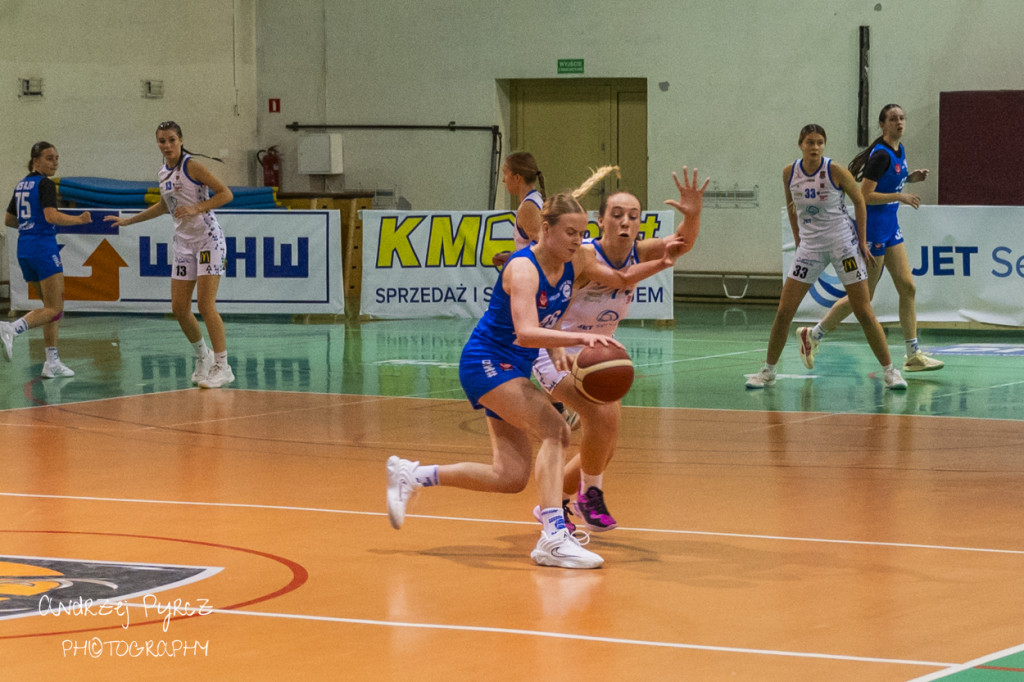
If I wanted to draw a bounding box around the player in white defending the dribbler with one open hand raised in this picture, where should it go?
[534,167,708,531]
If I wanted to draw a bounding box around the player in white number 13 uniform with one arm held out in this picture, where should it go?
[105,121,234,388]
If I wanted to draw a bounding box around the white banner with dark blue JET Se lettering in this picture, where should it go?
[782,206,1024,327]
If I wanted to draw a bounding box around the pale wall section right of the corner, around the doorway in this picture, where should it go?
[251,0,1024,272]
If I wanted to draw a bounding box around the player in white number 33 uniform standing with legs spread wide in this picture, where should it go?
[746,124,906,390]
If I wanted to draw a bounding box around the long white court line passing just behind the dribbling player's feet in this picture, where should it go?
[0,493,1024,556]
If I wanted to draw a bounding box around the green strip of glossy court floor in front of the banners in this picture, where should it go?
[0,303,1024,420]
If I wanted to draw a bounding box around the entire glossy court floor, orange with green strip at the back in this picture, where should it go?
[0,304,1024,680]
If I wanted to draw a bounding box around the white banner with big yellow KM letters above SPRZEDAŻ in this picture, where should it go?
[359,211,676,319]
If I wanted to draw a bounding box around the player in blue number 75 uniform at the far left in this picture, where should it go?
[0,142,92,379]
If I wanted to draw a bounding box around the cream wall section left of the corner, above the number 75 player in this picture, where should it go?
[0,0,257,280]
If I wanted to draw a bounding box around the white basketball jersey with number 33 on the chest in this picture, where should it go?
[790,157,857,251]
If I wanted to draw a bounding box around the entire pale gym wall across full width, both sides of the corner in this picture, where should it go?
[0,0,1024,280]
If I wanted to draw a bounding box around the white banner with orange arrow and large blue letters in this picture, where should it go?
[8,209,344,314]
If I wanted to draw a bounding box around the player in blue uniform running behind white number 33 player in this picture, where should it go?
[797,104,944,372]
